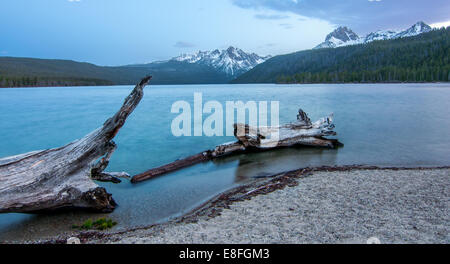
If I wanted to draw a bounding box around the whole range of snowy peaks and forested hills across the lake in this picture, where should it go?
[0,22,450,87]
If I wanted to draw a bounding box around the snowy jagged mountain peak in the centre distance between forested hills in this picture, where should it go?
[172,47,270,76]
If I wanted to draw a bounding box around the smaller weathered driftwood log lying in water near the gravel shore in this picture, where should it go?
[131,109,342,183]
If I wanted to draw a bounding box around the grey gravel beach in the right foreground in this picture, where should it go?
[93,169,450,244]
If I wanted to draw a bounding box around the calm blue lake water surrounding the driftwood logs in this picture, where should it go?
[0,84,450,241]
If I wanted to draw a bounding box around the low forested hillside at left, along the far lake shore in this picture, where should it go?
[0,57,230,87]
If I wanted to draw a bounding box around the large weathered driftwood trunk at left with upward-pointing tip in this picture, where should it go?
[0,76,151,213]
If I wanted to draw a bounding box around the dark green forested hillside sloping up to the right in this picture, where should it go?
[233,27,450,83]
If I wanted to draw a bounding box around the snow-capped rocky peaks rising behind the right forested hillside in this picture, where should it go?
[314,21,431,49]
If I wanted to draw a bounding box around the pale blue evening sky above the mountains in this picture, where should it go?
[0,0,450,65]
